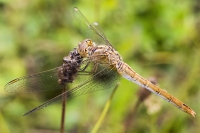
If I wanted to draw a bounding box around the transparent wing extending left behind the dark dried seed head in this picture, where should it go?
[5,67,63,93]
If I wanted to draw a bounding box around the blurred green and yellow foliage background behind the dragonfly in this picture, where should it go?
[0,0,200,133]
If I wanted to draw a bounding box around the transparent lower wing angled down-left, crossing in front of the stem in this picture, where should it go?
[24,65,120,115]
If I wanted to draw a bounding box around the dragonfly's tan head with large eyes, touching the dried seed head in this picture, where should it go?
[77,39,94,57]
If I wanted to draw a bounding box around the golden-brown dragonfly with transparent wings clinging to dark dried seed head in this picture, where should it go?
[5,7,196,117]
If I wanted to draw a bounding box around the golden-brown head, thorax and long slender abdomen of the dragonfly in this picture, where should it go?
[78,39,196,117]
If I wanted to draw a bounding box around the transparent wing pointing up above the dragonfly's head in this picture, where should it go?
[73,7,112,46]
